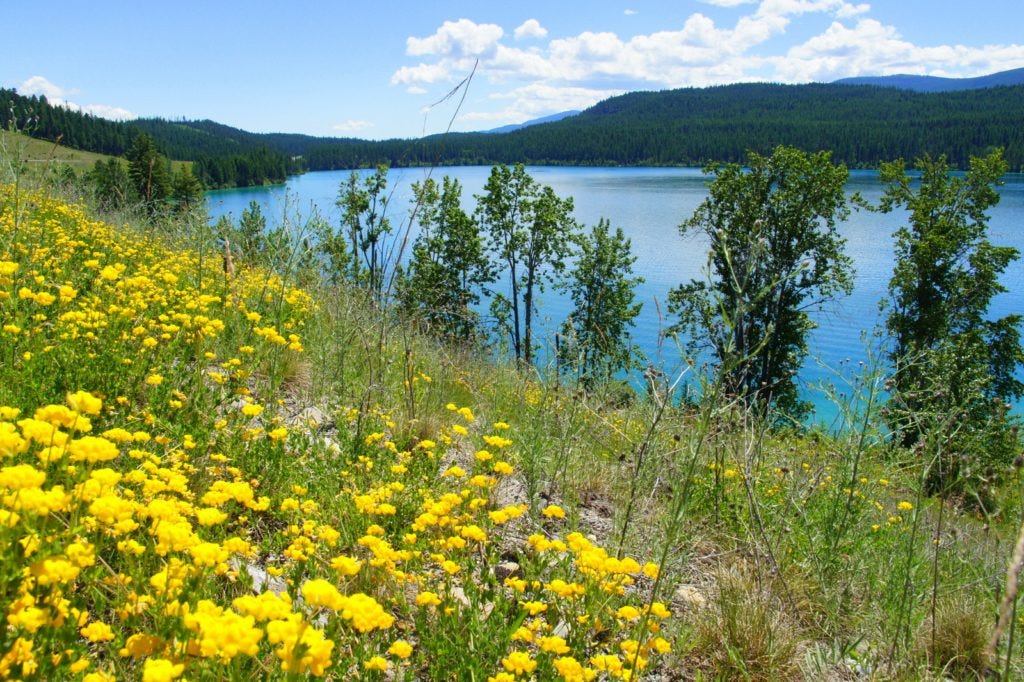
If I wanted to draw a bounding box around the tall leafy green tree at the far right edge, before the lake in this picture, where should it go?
[881,151,1024,505]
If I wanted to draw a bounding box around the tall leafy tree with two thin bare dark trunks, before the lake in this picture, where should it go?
[476,164,577,365]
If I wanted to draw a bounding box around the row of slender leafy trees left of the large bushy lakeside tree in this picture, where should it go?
[216,164,642,386]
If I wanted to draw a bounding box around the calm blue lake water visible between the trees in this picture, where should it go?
[207,166,1024,422]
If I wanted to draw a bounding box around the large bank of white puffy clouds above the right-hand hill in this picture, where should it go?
[391,0,1024,129]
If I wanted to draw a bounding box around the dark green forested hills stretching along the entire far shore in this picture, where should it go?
[0,79,1024,187]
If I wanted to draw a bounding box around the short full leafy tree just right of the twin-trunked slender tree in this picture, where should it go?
[559,219,643,388]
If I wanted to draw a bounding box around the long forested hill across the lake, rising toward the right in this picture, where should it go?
[305,84,1024,170]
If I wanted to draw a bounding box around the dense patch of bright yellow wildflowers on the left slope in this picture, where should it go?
[0,187,671,682]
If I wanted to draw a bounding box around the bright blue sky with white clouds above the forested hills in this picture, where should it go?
[6,0,1024,139]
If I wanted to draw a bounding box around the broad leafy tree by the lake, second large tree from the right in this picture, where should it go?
[669,146,853,419]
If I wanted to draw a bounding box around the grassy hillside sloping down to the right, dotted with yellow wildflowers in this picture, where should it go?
[0,163,1024,682]
